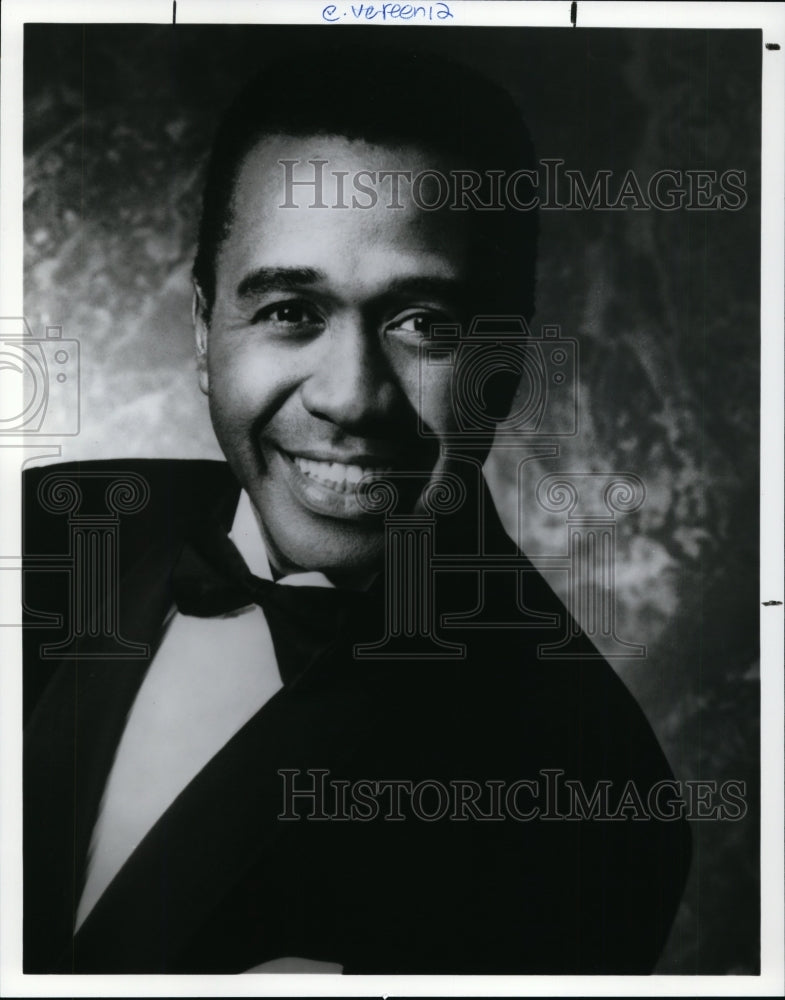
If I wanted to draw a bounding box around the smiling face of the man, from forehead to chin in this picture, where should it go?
[196,136,480,579]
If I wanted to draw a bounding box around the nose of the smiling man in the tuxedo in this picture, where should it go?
[302,319,400,435]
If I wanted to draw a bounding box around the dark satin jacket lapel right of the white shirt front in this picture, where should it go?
[64,636,402,973]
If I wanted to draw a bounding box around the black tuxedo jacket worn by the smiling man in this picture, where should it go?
[24,461,689,974]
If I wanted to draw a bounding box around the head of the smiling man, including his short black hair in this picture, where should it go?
[187,46,537,579]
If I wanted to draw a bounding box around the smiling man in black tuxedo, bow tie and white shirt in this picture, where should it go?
[25,44,689,973]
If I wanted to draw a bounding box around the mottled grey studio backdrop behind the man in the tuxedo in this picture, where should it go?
[24,25,761,973]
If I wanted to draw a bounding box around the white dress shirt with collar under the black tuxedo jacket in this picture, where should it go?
[76,491,332,930]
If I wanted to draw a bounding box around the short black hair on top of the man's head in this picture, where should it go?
[193,39,538,319]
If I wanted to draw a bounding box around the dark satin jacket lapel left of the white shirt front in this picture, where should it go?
[25,536,181,968]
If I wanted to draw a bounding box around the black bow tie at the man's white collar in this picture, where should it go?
[172,523,368,684]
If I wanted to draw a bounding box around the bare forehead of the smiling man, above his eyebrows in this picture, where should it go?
[220,134,467,275]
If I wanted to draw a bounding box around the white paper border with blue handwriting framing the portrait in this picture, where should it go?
[0,0,785,997]
